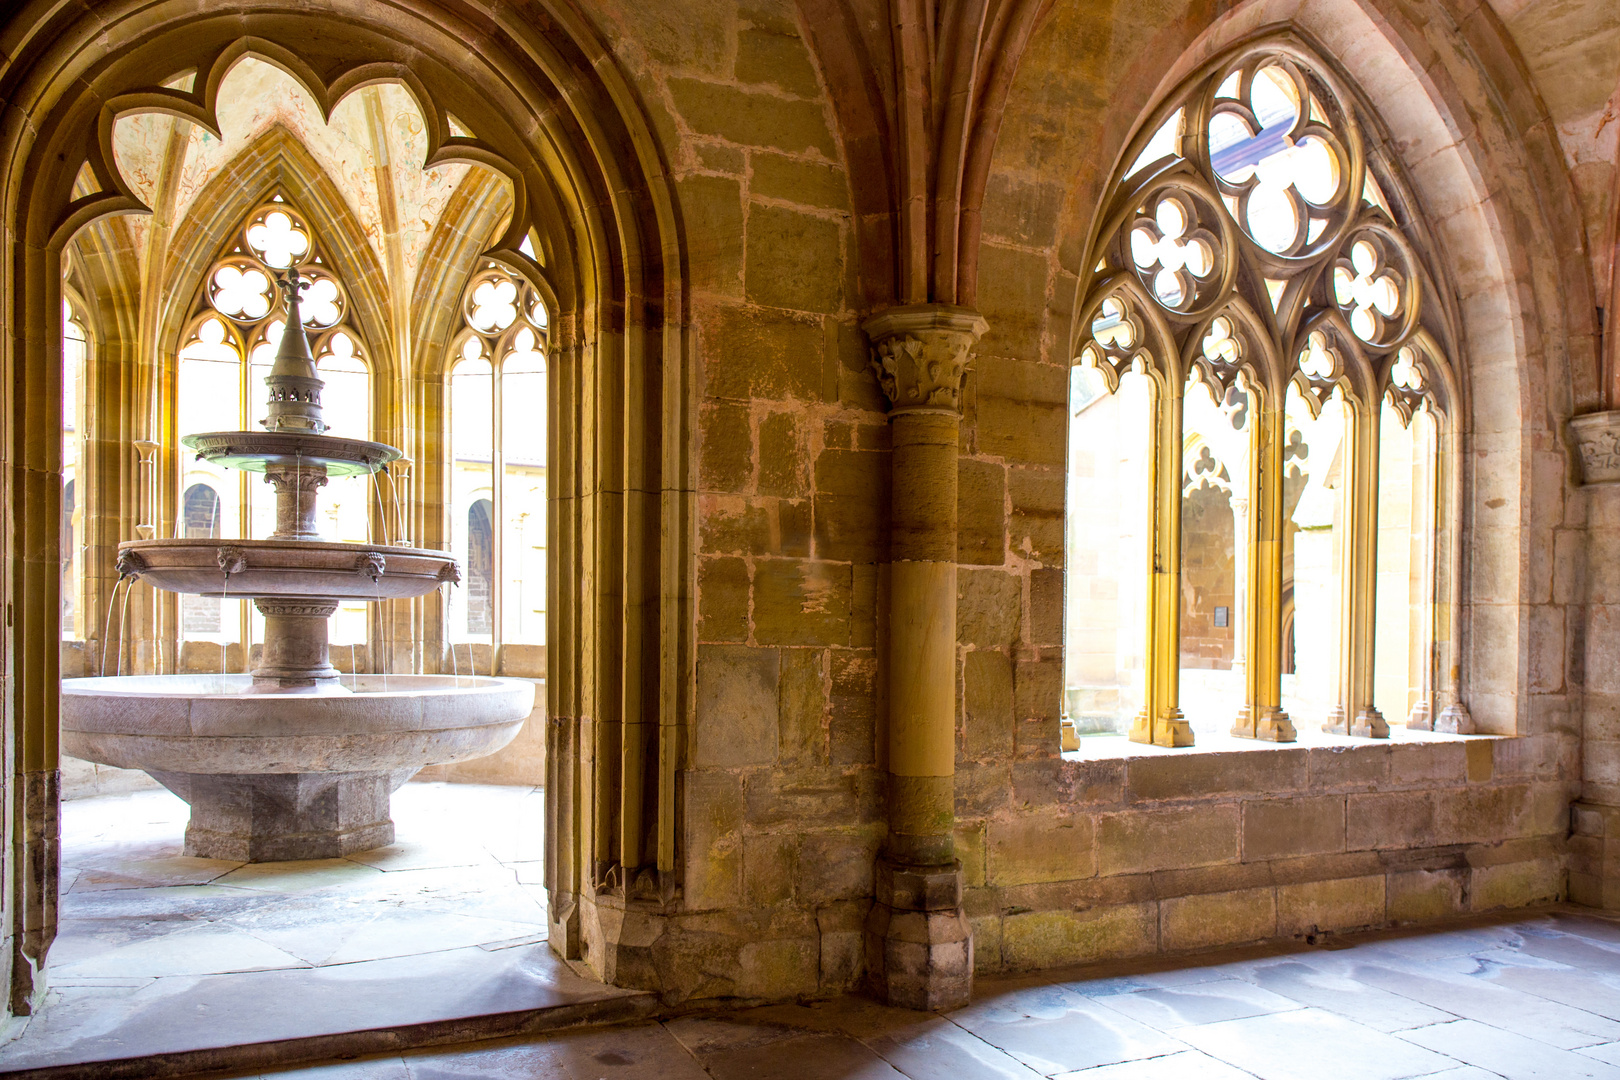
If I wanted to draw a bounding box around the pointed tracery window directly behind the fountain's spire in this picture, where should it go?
[175,196,376,644]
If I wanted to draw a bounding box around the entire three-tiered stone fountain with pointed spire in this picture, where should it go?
[62,269,535,861]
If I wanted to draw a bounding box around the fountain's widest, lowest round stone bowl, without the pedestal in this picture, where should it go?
[62,675,535,774]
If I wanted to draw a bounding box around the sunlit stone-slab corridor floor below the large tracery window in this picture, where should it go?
[249,912,1620,1080]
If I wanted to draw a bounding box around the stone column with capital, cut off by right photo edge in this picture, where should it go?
[1568,411,1620,910]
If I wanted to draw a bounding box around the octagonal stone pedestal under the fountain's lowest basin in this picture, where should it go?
[149,769,416,863]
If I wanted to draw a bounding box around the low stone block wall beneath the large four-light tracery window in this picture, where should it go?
[957,738,1573,972]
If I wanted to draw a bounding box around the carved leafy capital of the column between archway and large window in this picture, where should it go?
[860,304,988,415]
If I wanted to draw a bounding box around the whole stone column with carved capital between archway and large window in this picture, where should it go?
[862,304,985,1009]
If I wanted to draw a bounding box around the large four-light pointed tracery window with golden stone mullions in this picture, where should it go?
[1064,40,1453,746]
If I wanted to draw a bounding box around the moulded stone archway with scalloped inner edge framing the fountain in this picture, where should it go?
[0,0,695,1014]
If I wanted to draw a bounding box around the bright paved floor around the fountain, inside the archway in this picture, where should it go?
[0,784,641,1072]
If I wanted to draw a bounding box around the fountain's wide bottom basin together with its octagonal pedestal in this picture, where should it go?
[62,675,535,863]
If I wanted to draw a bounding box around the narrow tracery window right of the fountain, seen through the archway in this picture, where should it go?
[449,262,549,648]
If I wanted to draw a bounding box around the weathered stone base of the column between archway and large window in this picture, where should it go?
[867,857,974,1012]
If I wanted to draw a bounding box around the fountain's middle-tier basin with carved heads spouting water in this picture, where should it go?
[118,538,460,601]
